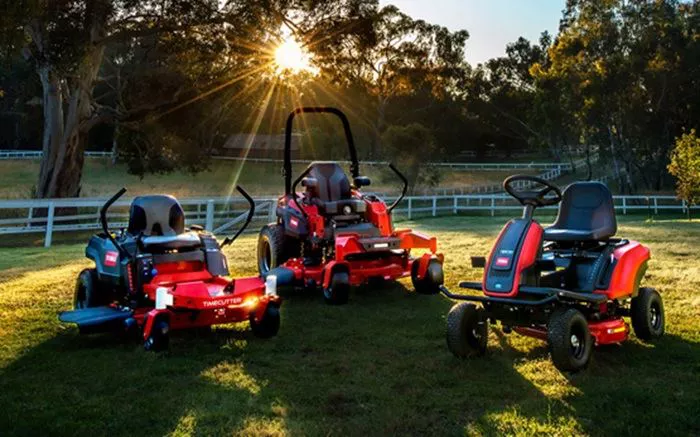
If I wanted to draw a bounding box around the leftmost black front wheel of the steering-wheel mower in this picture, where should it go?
[447,302,489,358]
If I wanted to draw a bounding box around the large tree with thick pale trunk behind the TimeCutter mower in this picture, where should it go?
[5,0,279,197]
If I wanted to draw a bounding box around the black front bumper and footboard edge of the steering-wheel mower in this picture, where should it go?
[440,281,607,306]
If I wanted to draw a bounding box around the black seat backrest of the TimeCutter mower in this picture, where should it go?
[127,194,185,237]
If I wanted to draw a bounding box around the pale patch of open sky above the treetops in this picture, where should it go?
[379,0,565,65]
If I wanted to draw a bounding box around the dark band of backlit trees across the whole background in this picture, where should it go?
[0,0,700,197]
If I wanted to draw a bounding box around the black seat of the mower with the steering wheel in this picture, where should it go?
[544,182,617,241]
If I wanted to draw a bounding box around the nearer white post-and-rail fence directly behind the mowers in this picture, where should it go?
[0,193,688,247]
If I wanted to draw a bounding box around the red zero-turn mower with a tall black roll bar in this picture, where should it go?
[258,107,443,304]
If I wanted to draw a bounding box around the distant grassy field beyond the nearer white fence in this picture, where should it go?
[0,158,532,199]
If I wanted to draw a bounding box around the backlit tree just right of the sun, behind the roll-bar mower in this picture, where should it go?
[304,1,469,157]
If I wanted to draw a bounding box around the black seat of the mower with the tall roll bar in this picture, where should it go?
[309,161,367,216]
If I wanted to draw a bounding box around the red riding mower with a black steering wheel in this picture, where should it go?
[441,175,664,371]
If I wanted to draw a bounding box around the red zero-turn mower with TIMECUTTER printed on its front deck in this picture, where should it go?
[59,187,281,351]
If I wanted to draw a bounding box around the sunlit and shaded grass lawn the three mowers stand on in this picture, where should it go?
[0,217,700,436]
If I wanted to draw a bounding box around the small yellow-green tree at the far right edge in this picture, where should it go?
[668,129,700,220]
